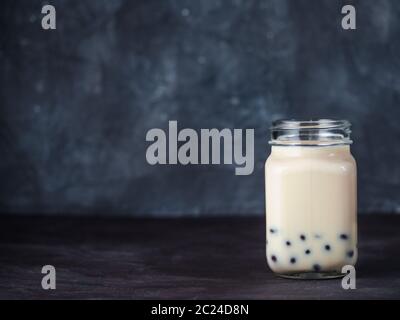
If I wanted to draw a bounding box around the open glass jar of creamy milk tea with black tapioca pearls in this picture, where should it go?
[265,120,357,279]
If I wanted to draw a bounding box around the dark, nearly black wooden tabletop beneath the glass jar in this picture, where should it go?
[0,215,400,299]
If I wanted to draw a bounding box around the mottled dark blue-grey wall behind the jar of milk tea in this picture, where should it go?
[0,0,400,216]
